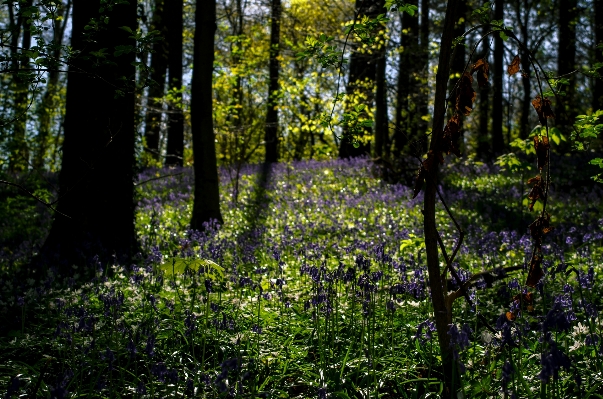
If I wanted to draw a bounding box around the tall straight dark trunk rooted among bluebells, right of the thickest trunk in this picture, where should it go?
[191,0,222,230]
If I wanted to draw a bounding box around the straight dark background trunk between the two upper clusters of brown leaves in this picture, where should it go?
[492,0,505,155]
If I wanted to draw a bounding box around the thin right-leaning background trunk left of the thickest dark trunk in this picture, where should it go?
[33,0,71,169]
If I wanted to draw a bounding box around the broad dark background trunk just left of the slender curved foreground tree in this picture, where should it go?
[394,1,420,158]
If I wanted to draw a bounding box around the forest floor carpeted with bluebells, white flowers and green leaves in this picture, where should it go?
[0,158,603,398]
